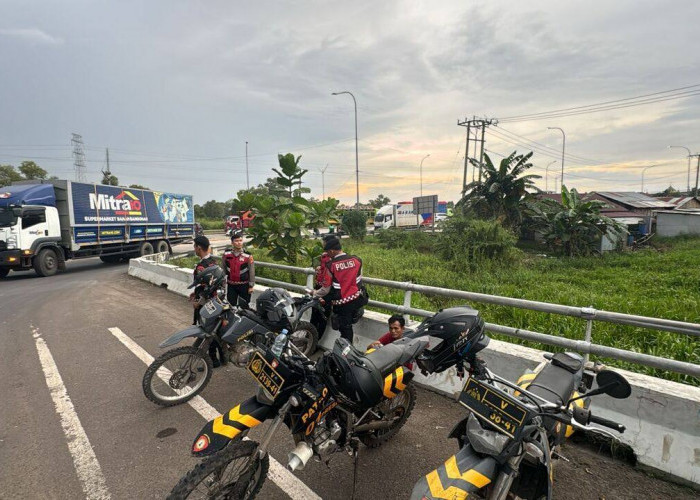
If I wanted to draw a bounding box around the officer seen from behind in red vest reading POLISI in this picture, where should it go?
[314,238,367,343]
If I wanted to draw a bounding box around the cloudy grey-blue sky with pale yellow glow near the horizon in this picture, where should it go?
[0,0,700,203]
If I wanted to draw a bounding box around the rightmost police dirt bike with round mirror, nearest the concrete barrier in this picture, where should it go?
[411,308,631,500]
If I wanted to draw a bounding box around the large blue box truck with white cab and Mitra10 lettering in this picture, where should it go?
[0,180,194,278]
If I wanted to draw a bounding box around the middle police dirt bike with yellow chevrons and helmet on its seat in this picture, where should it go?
[168,326,427,499]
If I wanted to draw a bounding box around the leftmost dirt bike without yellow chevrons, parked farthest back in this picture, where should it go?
[142,266,321,406]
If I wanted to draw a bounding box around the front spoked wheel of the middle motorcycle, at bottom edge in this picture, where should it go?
[167,440,270,500]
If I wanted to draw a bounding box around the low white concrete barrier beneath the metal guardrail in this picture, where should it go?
[129,258,700,488]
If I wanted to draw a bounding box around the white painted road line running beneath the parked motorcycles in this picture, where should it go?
[109,328,321,500]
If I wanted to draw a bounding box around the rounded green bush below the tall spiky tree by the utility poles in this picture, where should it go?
[437,215,519,264]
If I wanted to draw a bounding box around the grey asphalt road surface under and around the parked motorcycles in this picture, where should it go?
[0,259,693,499]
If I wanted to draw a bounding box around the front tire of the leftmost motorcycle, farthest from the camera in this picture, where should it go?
[141,346,214,406]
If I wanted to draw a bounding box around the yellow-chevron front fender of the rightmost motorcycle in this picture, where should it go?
[411,444,498,500]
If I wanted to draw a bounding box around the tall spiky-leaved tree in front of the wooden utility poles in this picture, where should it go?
[459,151,541,229]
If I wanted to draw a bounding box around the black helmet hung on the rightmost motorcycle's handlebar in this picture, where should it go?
[409,306,489,373]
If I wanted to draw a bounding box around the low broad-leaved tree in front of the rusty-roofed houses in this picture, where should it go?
[527,186,625,257]
